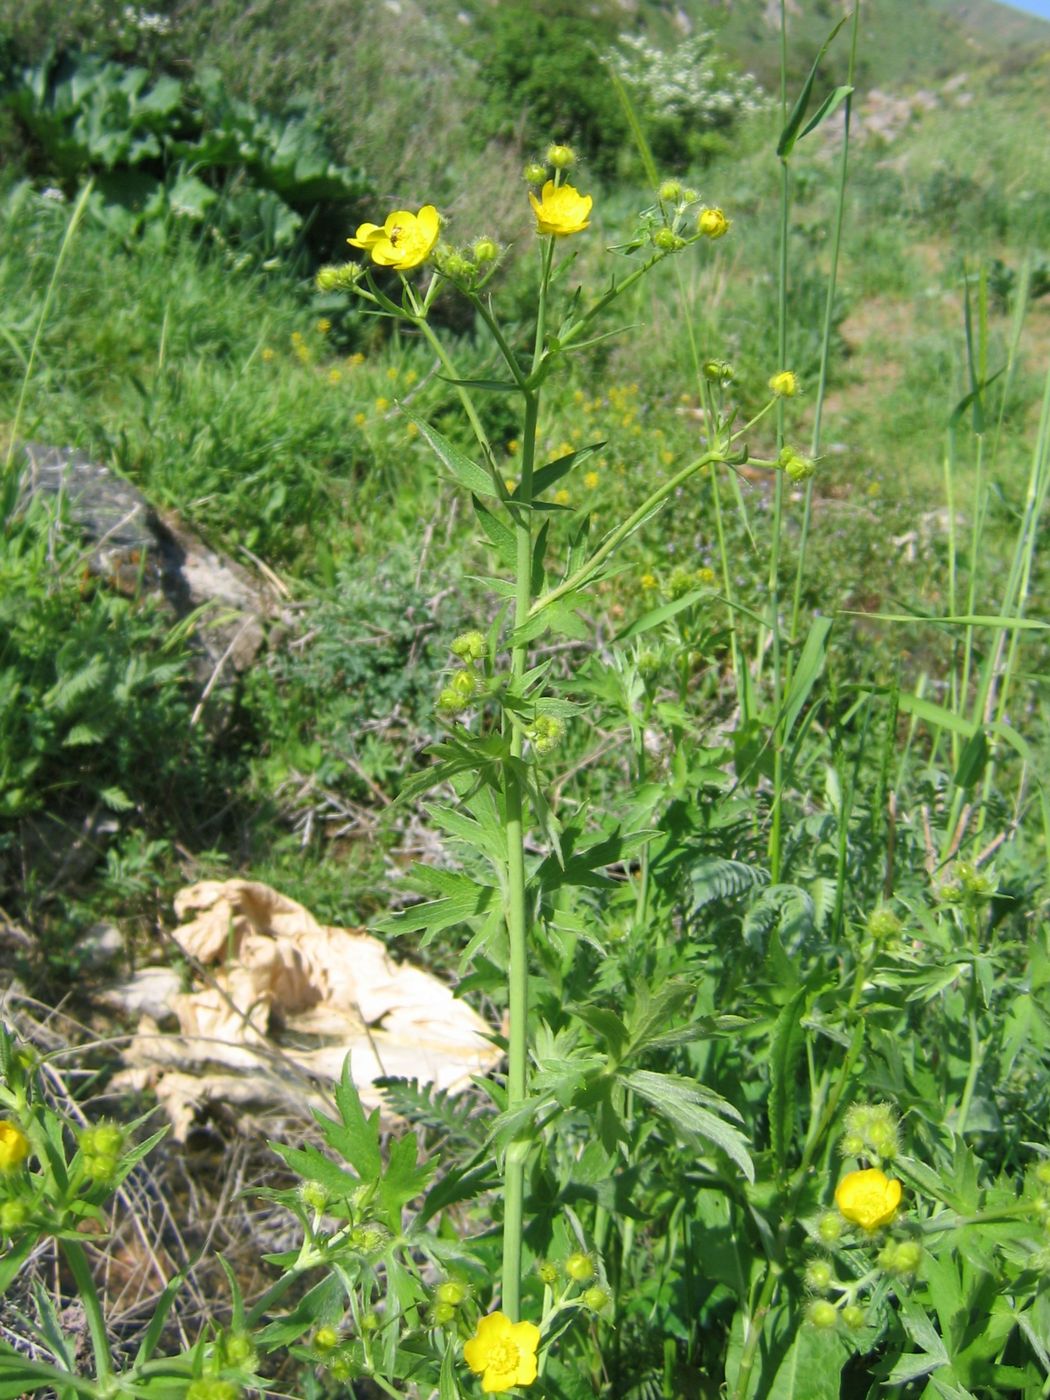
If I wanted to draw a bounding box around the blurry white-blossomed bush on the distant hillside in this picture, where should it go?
[608,29,767,127]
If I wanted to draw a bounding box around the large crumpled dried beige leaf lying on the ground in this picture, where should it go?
[119,879,501,1138]
